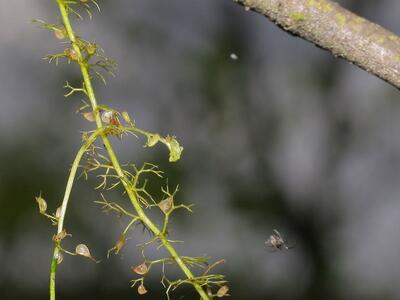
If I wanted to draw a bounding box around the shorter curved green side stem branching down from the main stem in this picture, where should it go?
[50,130,100,300]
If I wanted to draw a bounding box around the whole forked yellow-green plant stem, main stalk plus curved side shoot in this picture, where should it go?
[45,0,216,300]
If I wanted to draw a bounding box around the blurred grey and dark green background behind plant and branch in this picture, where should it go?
[0,0,400,300]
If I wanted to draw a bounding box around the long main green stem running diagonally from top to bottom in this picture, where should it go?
[52,0,209,300]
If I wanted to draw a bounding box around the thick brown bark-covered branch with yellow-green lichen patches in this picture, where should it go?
[234,0,400,88]
